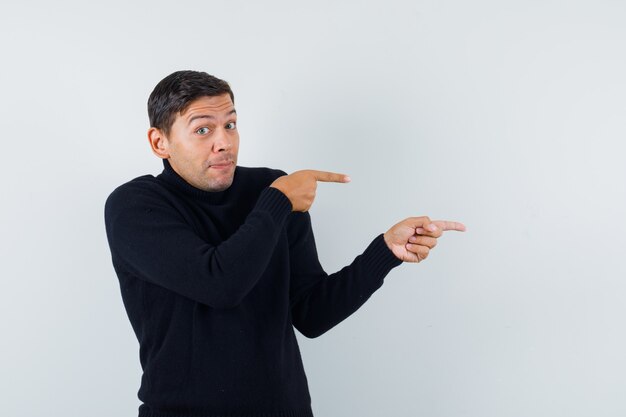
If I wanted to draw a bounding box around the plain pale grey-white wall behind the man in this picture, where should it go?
[0,0,626,417]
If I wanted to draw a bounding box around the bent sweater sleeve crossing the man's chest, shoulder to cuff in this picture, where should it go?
[105,182,292,309]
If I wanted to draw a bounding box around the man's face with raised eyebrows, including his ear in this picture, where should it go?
[148,93,239,191]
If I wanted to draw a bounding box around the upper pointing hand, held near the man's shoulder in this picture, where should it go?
[270,169,350,211]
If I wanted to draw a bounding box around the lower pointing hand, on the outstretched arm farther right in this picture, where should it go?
[384,216,466,262]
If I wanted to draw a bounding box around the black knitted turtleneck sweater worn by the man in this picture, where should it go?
[104,159,402,417]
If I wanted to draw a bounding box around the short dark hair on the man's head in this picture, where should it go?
[148,70,235,135]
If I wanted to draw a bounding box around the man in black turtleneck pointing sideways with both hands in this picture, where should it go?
[105,71,465,417]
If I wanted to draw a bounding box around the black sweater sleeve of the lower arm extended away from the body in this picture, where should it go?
[288,212,402,338]
